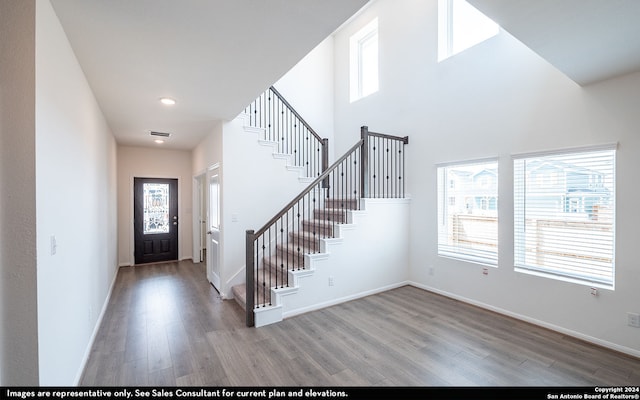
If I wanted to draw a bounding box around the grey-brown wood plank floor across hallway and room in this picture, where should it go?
[80,261,640,387]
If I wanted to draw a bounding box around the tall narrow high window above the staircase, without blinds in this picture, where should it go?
[349,18,378,102]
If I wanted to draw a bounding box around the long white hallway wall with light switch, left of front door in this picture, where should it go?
[35,1,117,385]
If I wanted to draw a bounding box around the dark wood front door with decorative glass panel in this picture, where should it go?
[133,178,178,264]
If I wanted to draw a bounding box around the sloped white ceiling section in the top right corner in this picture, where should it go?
[467,0,640,86]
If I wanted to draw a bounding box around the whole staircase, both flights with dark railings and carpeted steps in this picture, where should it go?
[231,87,408,326]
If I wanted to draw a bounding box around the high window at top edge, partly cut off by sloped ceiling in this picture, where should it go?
[438,0,500,61]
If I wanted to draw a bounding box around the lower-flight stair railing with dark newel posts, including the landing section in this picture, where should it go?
[246,126,409,326]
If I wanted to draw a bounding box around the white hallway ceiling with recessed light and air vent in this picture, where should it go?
[51,0,368,149]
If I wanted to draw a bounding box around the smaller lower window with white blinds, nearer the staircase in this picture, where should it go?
[438,159,498,266]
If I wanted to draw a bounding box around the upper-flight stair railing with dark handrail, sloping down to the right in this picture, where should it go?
[245,86,329,177]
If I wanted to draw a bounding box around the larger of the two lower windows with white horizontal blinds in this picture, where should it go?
[514,146,616,288]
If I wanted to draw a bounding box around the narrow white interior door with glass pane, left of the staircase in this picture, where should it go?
[207,169,221,292]
